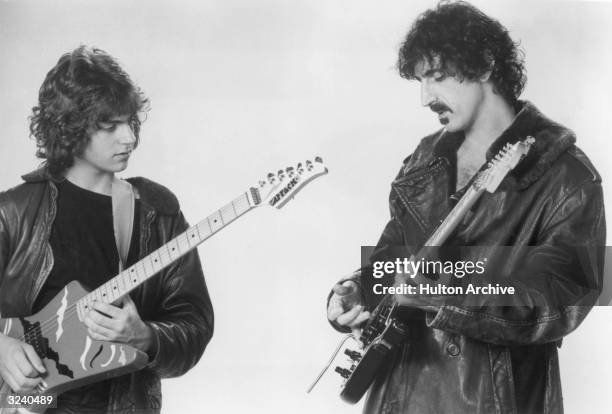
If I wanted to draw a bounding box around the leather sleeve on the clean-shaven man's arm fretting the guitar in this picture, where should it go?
[147,212,214,378]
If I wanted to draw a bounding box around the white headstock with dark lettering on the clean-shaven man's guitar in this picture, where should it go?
[250,157,327,209]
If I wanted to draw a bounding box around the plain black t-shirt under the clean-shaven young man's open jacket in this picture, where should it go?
[33,180,140,409]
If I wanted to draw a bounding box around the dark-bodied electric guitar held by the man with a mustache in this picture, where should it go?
[308,137,535,404]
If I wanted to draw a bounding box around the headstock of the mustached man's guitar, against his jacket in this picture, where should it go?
[474,136,535,193]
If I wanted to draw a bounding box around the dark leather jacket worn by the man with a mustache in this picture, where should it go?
[342,102,605,414]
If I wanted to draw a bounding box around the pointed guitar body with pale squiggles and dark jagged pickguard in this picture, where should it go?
[0,281,148,413]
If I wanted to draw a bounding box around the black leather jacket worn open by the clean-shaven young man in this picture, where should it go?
[0,169,213,414]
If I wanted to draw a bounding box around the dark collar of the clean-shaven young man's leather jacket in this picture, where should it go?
[21,165,179,215]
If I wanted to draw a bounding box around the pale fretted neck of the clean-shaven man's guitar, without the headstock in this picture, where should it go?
[77,188,261,319]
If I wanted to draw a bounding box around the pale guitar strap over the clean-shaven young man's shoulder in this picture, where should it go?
[111,177,135,271]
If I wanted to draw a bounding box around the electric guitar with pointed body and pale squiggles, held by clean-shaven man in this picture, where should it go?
[0,157,327,413]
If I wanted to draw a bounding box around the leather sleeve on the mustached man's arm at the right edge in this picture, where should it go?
[397,181,605,345]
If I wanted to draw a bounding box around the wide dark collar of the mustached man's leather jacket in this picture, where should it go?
[433,101,576,189]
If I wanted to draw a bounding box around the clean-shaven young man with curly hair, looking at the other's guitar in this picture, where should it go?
[0,46,213,413]
